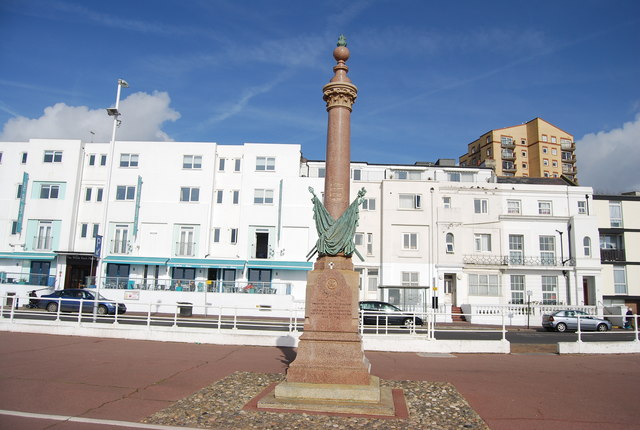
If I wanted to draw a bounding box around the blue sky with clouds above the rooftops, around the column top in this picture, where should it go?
[0,0,640,192]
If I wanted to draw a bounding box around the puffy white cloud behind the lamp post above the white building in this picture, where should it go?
[0,91,180,142]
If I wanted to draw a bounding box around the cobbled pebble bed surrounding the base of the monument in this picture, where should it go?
[142,372,489,430]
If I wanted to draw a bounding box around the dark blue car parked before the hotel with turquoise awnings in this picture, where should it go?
[38,289,127,315]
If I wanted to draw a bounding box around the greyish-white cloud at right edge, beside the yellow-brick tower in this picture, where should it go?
[576,114,640,194]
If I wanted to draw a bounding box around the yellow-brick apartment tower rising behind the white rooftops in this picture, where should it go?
[460,118,577,183]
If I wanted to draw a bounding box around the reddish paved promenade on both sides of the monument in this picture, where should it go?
[0,332,640,430]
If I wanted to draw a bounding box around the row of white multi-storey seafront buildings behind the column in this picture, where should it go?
[0,139,611,320]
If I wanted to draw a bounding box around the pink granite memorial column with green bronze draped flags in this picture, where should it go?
[276,36,371,388]
